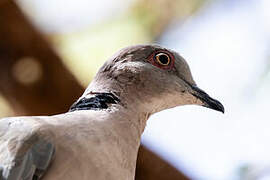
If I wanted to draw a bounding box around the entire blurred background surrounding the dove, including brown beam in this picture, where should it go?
[0,0,270,180]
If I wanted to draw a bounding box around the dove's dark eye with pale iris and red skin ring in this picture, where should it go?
[147,50,175,70]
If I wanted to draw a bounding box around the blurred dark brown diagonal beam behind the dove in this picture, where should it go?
[0,0,188,180]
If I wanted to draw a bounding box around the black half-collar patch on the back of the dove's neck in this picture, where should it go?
[69,92,120,112]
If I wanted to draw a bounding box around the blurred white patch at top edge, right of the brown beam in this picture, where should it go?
[16,0,133,32]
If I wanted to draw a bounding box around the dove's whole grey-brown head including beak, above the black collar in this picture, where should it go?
[83,45,224,113]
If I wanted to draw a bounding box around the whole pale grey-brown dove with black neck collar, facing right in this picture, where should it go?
[0,45,224,180]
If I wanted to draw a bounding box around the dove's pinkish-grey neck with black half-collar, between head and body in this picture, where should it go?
[75,74,156,136]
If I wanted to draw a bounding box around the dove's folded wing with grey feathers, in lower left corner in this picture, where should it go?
[0,118,55,180]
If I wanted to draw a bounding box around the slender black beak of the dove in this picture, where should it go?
[190,85,224,113]
